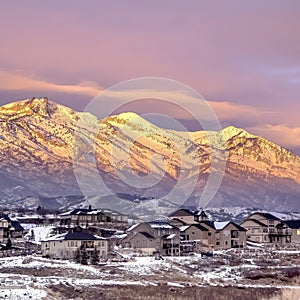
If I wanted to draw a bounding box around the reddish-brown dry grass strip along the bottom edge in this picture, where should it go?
[51,284,280,300]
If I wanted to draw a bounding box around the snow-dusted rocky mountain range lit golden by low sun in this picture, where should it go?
[0,98,300,211]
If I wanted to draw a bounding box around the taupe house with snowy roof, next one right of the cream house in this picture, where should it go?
[122,222,180,255]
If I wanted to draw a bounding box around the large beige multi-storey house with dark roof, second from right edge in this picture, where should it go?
[241,212,284,244]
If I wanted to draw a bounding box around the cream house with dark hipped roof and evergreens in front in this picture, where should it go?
[41,232,108,259]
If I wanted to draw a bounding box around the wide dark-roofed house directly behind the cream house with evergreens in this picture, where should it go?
[60,206,128,228]
